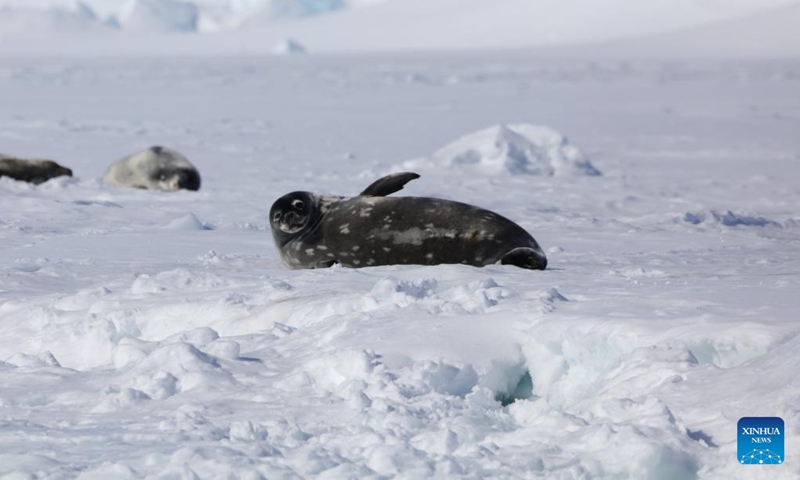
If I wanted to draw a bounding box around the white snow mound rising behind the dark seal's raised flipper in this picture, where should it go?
[403,123,601,176]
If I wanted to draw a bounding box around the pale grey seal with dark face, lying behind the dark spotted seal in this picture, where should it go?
[103,146,200,192]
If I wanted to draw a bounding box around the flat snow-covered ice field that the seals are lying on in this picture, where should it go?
[0,52,800,480]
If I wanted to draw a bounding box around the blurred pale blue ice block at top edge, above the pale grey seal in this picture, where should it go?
[117,0,199,32]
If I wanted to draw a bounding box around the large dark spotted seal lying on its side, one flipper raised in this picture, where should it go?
[269,172,547,270]
